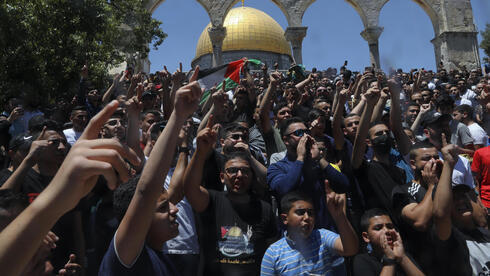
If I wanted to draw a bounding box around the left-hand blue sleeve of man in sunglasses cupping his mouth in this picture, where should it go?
[267,160,304,195]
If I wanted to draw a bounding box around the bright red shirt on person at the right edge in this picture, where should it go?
[471,146,490,208]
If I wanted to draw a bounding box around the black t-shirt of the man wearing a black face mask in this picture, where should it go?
[354,160,405,220]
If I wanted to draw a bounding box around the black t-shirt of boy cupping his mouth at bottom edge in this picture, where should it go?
[352,253,418,276]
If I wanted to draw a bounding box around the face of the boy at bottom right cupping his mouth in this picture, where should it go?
[362,215,397,251]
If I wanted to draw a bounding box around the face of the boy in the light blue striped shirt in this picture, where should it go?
[281,200,315,238]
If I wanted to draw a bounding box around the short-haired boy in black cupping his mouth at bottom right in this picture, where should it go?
[353,208,424,276]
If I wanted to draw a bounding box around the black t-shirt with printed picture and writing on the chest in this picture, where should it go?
[201,190,277,276]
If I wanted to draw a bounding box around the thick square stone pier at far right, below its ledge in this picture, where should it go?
[431,32,481,70]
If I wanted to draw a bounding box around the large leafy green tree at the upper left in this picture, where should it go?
[0,0,167,104]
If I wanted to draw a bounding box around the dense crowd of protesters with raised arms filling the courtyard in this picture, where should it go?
[0,58,490,276]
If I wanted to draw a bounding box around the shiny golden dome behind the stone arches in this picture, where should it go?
[195,7,291,58]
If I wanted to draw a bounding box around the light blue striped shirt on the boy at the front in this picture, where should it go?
[260,229,343,276]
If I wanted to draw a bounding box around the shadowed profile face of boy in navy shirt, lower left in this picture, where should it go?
[148,193,179,244]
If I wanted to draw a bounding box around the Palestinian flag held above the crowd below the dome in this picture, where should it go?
[197,59,262,104]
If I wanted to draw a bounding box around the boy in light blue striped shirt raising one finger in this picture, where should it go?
[261,187,359,276]
